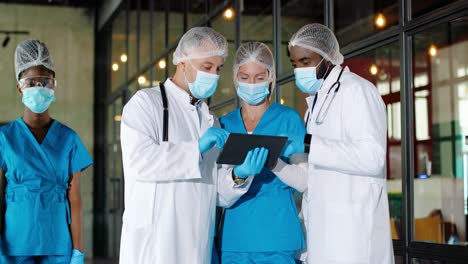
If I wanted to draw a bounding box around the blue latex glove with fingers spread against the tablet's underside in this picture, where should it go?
[234,148,268,179]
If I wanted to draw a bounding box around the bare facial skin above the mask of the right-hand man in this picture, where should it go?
[289,46,333,79]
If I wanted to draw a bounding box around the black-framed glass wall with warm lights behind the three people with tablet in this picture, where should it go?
[97,0,468,263]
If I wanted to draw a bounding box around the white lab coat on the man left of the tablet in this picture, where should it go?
[120,79,252,264]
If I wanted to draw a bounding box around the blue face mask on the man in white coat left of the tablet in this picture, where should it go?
[185,63,219,99]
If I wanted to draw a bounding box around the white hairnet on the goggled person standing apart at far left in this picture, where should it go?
[15,39,55,80]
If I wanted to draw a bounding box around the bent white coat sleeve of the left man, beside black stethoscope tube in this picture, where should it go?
[121,92,201,182]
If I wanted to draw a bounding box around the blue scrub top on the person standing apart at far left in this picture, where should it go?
[0,118,93,256]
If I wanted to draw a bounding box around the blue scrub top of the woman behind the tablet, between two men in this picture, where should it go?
[220,103,306,252]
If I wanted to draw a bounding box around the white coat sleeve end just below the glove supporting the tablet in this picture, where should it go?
[216,165,253,208]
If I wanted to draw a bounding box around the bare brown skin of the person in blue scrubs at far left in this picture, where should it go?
[12,66,83,252]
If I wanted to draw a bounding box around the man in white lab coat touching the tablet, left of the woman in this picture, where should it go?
[120,27,268,264]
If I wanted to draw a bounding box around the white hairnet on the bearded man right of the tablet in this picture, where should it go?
[288,23,343,65]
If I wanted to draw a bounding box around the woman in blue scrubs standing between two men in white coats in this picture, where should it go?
[220,42,306,264]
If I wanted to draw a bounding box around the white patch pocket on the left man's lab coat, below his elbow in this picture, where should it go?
[124,181,156,229]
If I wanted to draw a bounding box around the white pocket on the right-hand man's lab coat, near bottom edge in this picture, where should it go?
[325,202,370,264]
